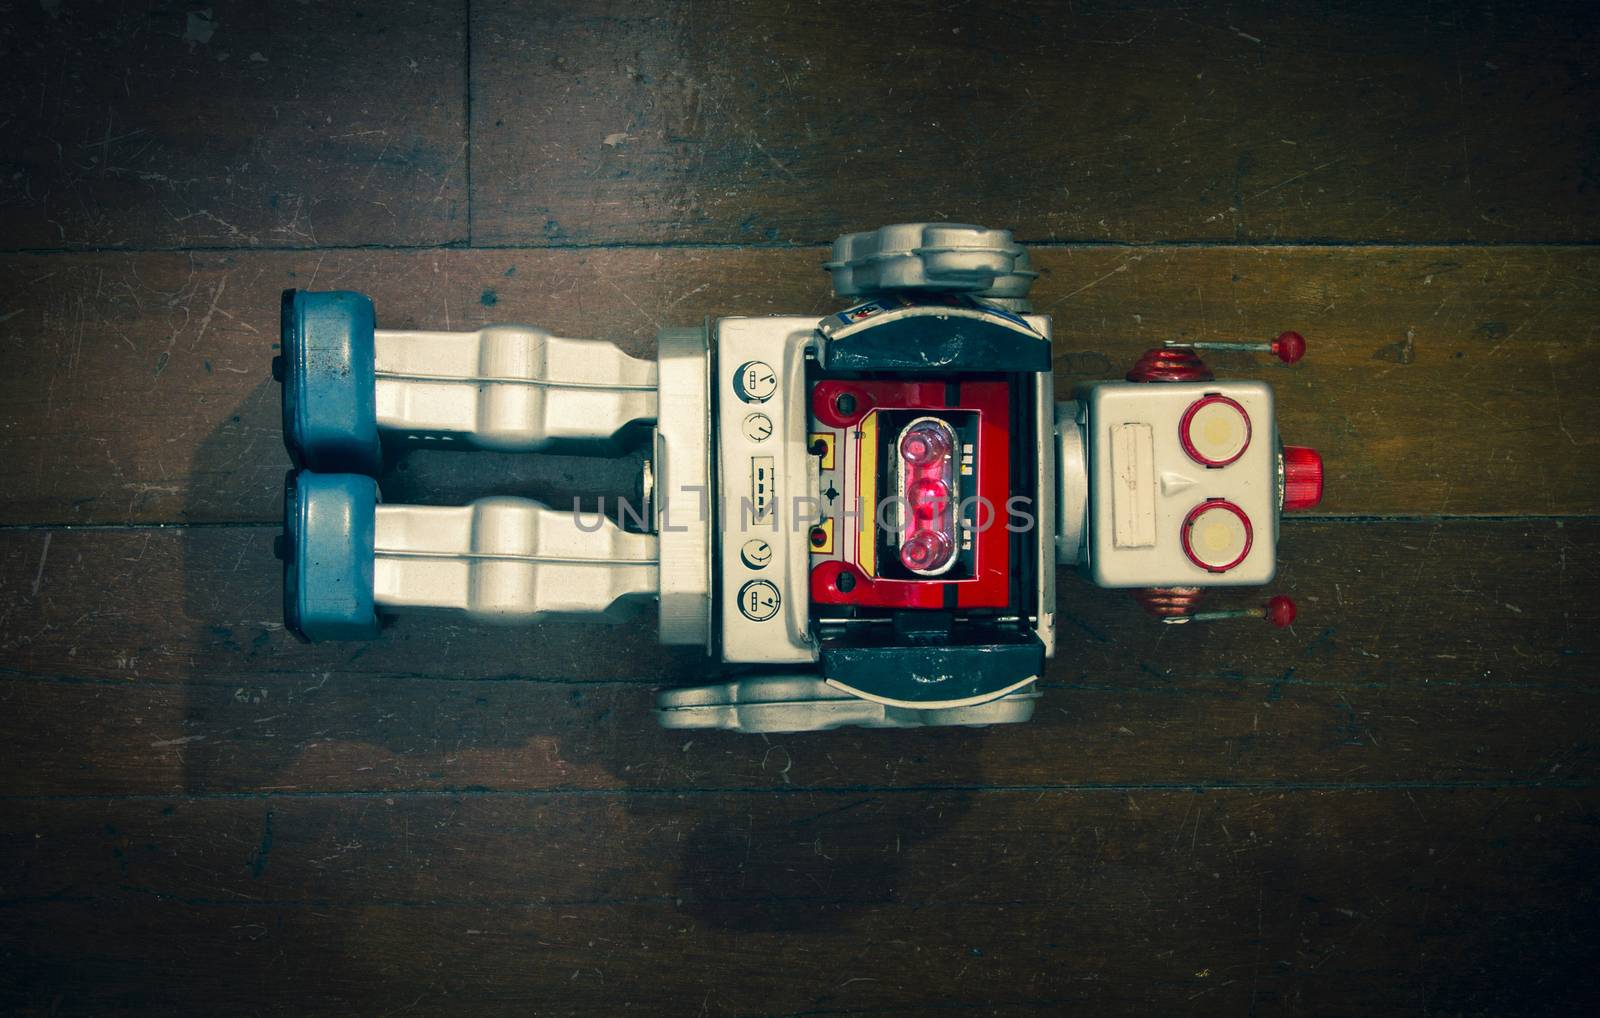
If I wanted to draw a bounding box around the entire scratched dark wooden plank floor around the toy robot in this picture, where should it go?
[0,0,1600,1018]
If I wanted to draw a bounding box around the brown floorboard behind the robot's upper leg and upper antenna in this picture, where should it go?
[0,248,1600,523]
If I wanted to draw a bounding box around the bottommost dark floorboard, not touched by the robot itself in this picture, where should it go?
[0,788,1600,1015]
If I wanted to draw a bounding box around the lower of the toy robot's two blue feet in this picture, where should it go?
[280,471,378,642]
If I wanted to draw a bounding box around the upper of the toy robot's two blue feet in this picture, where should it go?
[282,290,382,475]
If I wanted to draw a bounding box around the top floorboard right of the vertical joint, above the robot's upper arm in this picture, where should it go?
[472,0,1600,245]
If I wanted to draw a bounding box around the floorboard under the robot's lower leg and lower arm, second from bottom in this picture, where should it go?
[0,522,1600,796]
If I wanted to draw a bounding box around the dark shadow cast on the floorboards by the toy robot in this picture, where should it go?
[184,371,986,930]
